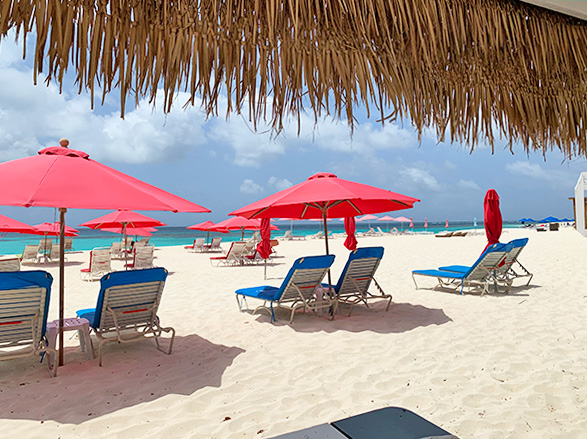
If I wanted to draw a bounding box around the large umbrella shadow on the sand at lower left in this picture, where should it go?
[0,335,245,424]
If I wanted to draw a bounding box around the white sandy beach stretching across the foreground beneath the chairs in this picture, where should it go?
[0,229,587,439]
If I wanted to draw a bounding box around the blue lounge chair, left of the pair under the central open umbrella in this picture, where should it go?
[236,255,336,323]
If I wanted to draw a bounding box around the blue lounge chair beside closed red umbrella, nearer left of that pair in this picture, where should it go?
[412,244,512,295]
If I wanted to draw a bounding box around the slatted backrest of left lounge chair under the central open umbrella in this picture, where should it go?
[275,255,334,302]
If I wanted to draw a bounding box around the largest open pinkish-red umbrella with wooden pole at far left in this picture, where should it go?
[0,144,210,365]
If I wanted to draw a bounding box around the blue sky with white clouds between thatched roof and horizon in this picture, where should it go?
[0,35,587,226]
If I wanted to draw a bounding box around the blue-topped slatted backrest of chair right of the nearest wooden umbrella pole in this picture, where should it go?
[90,268,167,333]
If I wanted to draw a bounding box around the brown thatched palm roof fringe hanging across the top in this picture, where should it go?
[0,0,587,157]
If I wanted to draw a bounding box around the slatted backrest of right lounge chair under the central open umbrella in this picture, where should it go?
[334,247,383,296]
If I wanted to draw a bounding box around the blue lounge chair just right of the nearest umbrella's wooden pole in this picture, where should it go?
[77,268,175,366]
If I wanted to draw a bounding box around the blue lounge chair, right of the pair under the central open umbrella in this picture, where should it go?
[322,247,391,316]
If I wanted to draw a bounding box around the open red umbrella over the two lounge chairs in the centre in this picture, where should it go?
[230,172,420,253]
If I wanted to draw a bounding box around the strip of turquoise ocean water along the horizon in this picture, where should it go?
[0,220,519,255]
